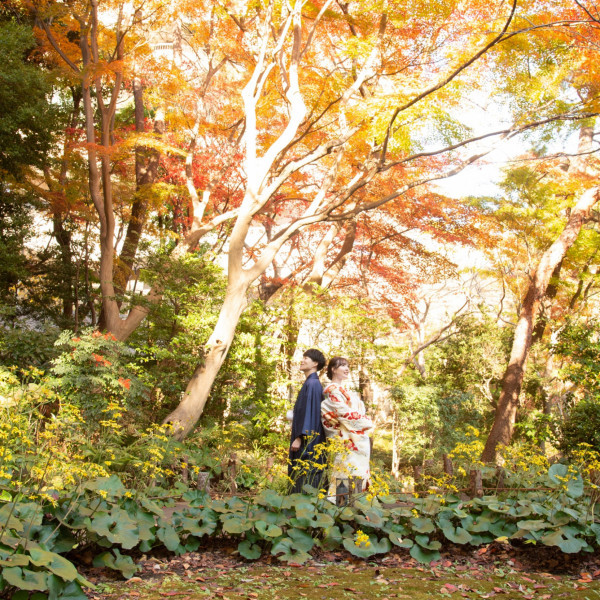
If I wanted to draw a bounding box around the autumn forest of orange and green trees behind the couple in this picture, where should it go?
[0,0,600,589]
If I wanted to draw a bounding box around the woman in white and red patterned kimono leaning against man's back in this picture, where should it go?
[321,356,374,494]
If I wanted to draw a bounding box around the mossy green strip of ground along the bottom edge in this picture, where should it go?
[94,563,600,600]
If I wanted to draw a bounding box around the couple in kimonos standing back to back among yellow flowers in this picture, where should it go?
[288,348,374,495]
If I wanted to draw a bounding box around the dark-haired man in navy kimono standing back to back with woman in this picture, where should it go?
[288,348,326,493]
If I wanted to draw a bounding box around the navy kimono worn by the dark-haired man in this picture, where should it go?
[288,373,327,493]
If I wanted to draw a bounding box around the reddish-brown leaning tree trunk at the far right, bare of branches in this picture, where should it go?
[481,187,600,462]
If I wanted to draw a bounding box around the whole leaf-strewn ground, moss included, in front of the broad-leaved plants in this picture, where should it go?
[85,543,600,600]
